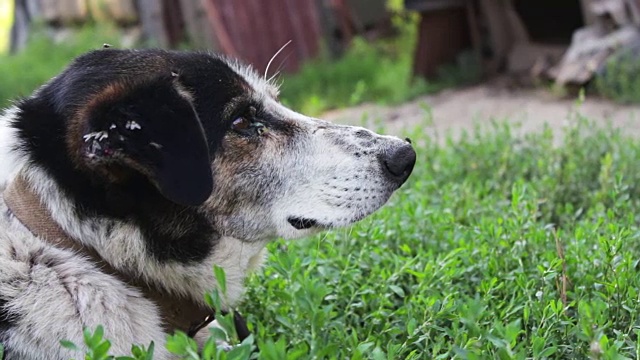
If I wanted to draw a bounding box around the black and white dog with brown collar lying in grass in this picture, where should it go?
[0,48,416,360]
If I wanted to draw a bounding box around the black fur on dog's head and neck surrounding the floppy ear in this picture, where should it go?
[14,49,247,263]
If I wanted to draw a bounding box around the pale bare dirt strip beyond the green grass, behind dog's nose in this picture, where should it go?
[323,83,640,138]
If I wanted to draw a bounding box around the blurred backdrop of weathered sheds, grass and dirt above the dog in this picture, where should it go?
[0,0,640,129]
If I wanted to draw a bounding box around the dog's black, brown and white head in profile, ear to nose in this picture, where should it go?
[17,49,416,245]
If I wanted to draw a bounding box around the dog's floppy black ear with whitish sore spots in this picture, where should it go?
[68,73,213,206]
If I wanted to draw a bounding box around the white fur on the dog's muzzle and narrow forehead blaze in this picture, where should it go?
[216,66,406,239]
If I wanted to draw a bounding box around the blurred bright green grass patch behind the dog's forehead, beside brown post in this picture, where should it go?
[276,34,479,115]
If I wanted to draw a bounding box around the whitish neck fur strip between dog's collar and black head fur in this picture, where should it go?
[11,165,265,306]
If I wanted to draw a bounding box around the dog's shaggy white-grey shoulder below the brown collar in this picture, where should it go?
[0,204,169,359]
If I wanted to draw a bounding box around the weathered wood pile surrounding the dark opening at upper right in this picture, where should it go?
[478,0,640,85]
